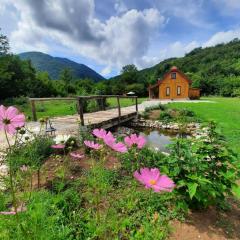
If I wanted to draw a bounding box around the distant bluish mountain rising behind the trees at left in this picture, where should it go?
[19,52,104,82]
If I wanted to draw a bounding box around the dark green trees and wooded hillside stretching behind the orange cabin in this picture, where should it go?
[0,29,240,100]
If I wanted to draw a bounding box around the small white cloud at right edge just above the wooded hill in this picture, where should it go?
[203,29,240,47]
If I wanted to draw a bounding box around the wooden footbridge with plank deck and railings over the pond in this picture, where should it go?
[29,95,138,133]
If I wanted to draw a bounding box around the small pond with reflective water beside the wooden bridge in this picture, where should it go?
[135,128,188,153]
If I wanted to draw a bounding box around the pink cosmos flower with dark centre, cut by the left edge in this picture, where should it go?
[0,105,25,135]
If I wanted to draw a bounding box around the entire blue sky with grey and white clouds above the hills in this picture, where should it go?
[0,0,240,77]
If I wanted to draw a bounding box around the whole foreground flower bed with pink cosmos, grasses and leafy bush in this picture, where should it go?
[0,107,240,240]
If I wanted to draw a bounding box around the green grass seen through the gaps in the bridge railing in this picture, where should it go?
[17,98,146,118]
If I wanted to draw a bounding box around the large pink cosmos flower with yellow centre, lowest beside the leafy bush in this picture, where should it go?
[133,168,175,192]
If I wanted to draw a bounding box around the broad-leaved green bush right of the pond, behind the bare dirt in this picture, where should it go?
[163,123,240,208]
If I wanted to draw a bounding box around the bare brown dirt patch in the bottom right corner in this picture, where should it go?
[169,200,240,240]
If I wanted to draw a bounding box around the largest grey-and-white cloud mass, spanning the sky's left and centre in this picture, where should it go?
[3,0,165,71]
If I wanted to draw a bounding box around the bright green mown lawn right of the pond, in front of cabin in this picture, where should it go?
[170,97,240,154]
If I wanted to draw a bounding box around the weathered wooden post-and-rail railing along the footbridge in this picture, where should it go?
[29,95,138,126]
